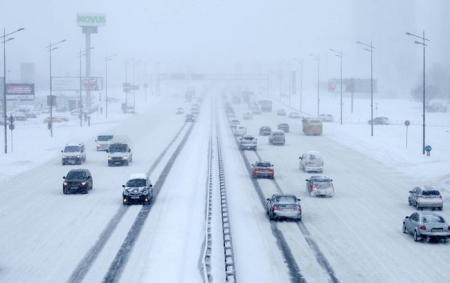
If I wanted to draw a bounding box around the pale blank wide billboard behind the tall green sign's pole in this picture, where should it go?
[52,77,103,91]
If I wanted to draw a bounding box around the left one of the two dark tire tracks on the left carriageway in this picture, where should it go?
[68,123,187,283]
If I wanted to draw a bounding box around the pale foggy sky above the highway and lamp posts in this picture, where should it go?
[0,0,450,92]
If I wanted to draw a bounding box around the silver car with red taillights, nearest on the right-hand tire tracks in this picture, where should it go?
[266,194,302,221]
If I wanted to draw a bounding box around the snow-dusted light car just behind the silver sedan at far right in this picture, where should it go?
[408,186,444,210]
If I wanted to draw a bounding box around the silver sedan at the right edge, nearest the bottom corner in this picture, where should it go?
[403,212,450,242]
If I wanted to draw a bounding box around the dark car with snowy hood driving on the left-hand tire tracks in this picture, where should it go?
[122,173,153,205]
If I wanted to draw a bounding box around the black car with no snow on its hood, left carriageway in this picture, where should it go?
[63,169,94,195]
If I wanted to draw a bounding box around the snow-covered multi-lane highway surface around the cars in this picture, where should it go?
[0,93,450,282]
